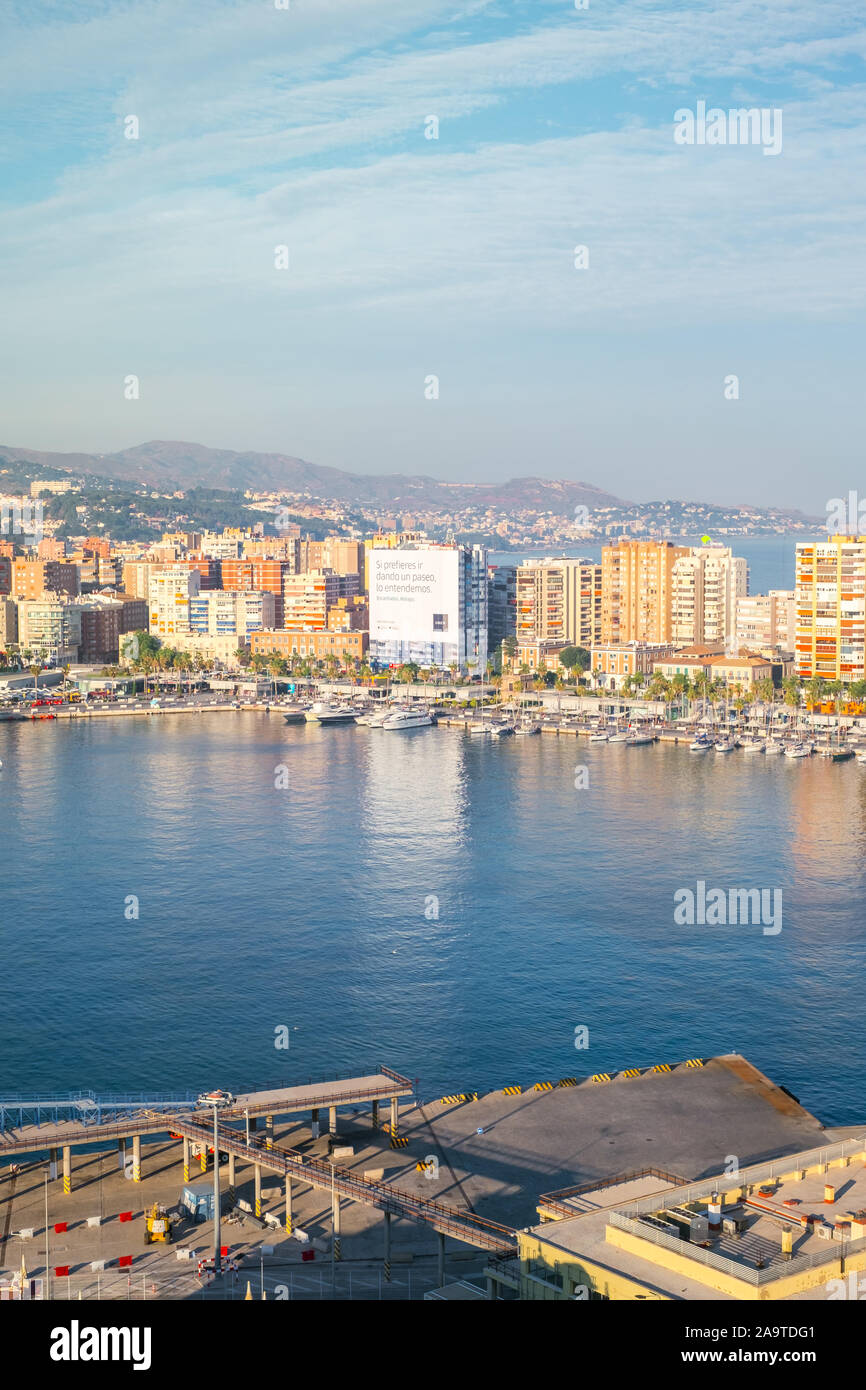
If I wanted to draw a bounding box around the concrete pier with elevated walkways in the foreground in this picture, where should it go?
[0,1055,831,1297]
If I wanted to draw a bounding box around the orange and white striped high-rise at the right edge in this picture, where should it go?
[795,535,866,681]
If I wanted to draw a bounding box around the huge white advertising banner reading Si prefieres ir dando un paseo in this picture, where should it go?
[368,548,460,645]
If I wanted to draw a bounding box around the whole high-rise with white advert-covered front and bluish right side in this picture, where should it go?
[367,542,487,674]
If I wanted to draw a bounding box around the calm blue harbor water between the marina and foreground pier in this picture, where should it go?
[0,713,866,1123]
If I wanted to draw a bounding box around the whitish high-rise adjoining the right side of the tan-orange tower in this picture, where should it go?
[670,545,749,645]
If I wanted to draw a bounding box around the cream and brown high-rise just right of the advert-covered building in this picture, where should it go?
[517,559,602,652]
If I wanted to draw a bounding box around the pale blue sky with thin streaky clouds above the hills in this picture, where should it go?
[0,0,866,514]
